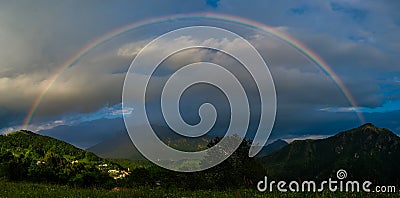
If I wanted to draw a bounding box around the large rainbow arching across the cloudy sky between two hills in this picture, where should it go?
[22,13,365,129]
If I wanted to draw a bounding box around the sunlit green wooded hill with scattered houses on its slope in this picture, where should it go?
[0,130,128,186]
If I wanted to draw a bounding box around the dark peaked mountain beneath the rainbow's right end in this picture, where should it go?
[262,124,400,183]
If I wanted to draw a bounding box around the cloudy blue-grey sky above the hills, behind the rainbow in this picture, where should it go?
[0,0,400,147]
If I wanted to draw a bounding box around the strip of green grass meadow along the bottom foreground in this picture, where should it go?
[0,181,399,197]
